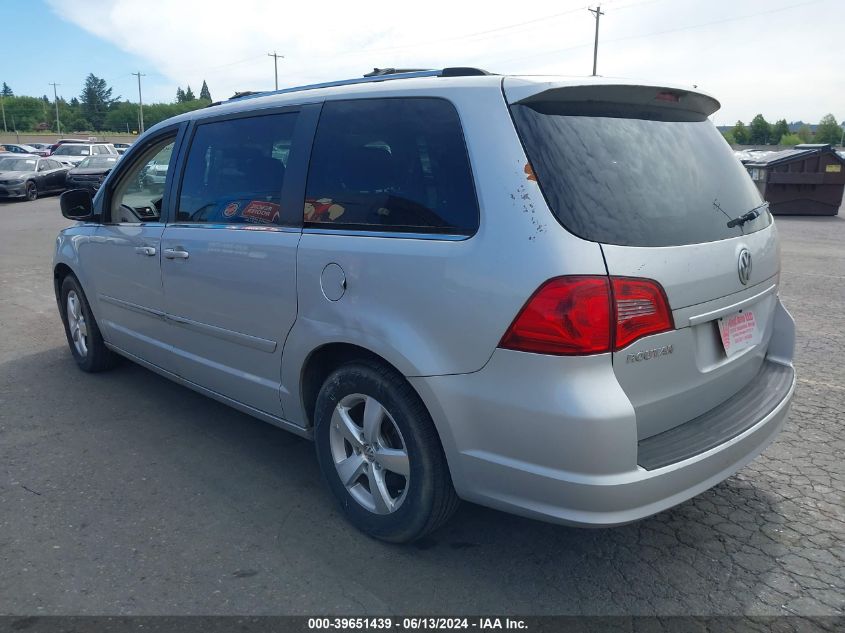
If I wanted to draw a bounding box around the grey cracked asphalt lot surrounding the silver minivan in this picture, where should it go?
[0,197,845,615]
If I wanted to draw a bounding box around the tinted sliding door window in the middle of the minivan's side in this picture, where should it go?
[177,113,296,225]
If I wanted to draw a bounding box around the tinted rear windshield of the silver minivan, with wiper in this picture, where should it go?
[512,102,771,246]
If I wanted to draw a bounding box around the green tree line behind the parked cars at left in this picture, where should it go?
[0,73,211,132]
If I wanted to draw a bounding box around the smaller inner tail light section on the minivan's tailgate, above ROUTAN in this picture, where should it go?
[611,277,675,350]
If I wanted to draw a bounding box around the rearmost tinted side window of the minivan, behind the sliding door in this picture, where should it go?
[304,98,478,235]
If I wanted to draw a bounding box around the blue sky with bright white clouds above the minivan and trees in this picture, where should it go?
[0,0,845,125]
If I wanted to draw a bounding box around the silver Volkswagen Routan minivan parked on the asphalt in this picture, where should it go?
[54,68,795,542]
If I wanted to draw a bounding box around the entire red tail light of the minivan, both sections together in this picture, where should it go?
[499,276,674,356]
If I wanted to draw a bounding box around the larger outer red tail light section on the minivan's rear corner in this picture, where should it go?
[499,277,611,355]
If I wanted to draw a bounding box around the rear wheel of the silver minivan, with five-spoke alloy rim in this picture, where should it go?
[314,361,459,543]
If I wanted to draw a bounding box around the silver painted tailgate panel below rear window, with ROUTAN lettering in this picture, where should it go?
[602,225,779,439]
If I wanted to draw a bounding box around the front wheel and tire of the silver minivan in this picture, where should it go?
[59,275,117,373]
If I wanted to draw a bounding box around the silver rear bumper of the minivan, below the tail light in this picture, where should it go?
[411,298,795,527]
